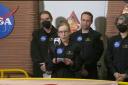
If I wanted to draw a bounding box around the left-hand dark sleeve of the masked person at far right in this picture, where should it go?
[105,39,116,74]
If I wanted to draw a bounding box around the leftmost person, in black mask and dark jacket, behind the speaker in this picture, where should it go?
[31,11,57,77]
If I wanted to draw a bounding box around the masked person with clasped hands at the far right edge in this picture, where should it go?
[106,14,128,81]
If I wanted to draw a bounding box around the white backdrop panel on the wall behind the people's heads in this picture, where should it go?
[44,1,108,29]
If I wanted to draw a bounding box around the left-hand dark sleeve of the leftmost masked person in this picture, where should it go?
[31,31,41,63]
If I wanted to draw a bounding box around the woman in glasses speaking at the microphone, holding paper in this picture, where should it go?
[46,21,81,78]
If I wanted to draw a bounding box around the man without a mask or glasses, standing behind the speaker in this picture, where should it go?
[71,11,104,79]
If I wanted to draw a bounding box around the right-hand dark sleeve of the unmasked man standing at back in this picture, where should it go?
[85,33,104,65]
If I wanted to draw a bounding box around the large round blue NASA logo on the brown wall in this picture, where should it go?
[0,4,18,39]
